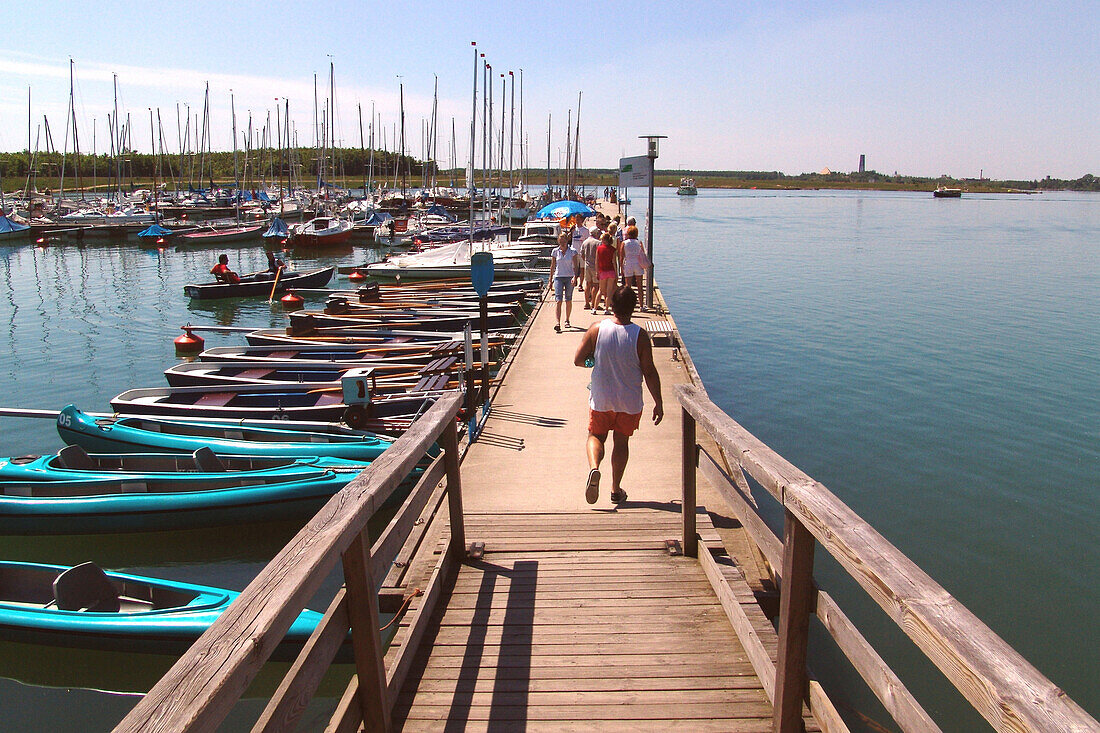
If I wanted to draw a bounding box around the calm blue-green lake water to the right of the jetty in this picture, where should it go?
[635,183,1100,730]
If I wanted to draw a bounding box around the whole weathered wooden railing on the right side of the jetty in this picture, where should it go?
[678,386,1100,732]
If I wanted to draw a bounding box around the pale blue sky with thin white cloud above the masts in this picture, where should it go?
[0,0,1100,178]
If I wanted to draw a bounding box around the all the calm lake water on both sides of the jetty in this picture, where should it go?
[0,190,1100,731]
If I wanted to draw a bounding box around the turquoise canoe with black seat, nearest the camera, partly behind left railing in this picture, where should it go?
[0,561,322,660]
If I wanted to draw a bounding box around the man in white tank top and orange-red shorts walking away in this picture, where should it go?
[573,286,664,504]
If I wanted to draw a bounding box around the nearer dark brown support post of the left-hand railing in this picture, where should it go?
[343,527,391,733]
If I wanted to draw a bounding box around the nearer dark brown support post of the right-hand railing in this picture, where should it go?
[771,510,814,733]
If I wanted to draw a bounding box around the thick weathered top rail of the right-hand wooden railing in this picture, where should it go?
[677,385,1100,731]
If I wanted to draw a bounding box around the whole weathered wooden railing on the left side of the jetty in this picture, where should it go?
[116,393,465,732]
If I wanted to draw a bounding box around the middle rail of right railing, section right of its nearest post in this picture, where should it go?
[816,591,939,733]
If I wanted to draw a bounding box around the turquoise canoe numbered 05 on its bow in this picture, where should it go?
[57,405,393,461]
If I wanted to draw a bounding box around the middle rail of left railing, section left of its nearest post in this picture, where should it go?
[252,588,350,733]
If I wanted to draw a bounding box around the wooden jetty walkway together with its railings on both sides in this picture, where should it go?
[117,202,1100,732]
